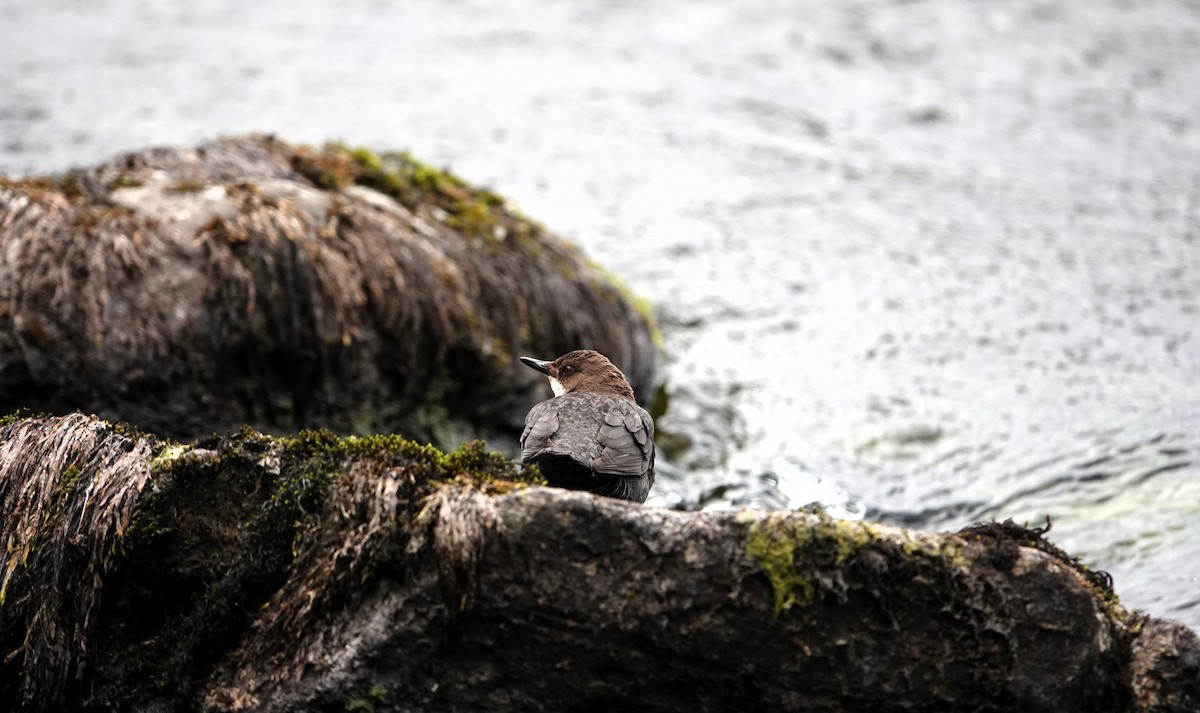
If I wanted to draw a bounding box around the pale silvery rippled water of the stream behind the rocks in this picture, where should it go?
[0,0,1200,628]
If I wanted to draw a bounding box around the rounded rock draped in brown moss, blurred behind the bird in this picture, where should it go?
[0,137,655,444]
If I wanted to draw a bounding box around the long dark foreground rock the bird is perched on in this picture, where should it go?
[0,414,1200,713]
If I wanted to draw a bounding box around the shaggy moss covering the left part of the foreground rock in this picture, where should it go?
[0,414,544,709]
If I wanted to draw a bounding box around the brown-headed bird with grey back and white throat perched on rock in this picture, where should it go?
[521,349,654,503]
